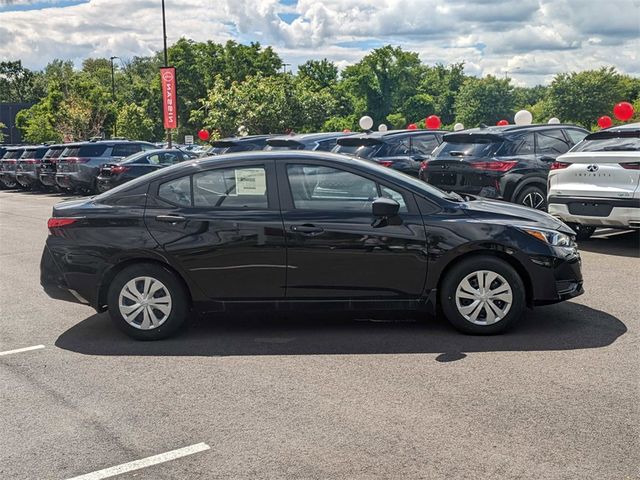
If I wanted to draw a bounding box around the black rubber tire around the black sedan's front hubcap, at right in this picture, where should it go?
[439,255,526,335]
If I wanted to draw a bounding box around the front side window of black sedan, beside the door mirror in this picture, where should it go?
[287,165,407,213]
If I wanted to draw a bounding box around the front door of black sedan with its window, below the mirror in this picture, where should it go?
[277,159,427,300]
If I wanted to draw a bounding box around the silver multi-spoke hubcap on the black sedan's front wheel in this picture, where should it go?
[456,270,513,325]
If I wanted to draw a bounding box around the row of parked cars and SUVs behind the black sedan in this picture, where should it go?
[0,124,640,237]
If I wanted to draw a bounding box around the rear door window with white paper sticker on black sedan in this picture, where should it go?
[193,167,269,208]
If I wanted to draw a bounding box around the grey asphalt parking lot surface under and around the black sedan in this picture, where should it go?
[0,191,640,479]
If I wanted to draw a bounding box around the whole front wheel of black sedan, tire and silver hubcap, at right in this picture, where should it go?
[440,256,526,335]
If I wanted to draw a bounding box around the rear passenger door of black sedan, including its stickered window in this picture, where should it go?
[145,160,287,300]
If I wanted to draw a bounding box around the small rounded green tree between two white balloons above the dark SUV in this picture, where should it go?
[455,75,515,128]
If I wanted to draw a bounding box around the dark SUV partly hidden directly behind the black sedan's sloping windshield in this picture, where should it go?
[333,130,445,177]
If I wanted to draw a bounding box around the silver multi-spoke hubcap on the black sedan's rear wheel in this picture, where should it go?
[118,277,171,330]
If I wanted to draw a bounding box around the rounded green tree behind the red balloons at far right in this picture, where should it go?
[547,67,631,128]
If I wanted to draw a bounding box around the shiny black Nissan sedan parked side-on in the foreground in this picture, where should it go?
[41,151,583,340]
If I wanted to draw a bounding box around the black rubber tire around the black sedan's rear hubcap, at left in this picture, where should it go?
[107,263,190,340]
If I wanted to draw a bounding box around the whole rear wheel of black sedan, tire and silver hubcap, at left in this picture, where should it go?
[107,263,189,340]
